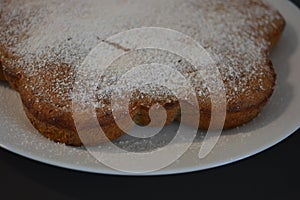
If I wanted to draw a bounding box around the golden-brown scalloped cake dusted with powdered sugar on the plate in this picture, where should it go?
[0,0,285,146]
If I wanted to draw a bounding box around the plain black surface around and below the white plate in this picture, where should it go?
[0,0,300,199]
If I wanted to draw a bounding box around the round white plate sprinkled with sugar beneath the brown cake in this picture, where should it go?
[0,0,300,175]
